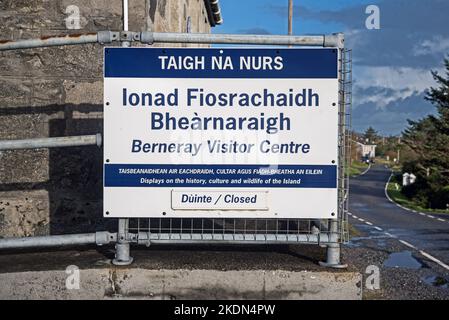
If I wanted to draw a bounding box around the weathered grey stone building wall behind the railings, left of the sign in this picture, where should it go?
[0,0,210,237]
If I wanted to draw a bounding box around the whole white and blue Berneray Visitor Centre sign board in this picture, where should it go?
[104,48,338,219]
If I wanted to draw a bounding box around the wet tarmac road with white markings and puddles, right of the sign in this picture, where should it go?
[343,164,449,299]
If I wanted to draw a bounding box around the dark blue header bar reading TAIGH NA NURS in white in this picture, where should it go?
[104,48,338,79]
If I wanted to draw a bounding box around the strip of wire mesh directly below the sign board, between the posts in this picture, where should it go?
[127,218,332,243]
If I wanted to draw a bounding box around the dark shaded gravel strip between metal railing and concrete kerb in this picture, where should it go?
[0,245,339,273]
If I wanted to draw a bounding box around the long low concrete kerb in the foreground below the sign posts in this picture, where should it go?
[0,268,362,300]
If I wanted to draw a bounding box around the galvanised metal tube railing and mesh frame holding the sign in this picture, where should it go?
[0,15,352,267]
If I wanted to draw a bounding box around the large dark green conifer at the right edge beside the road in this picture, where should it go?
[403,59,449,208]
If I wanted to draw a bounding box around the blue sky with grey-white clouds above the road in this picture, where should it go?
[213,0,449,135]
